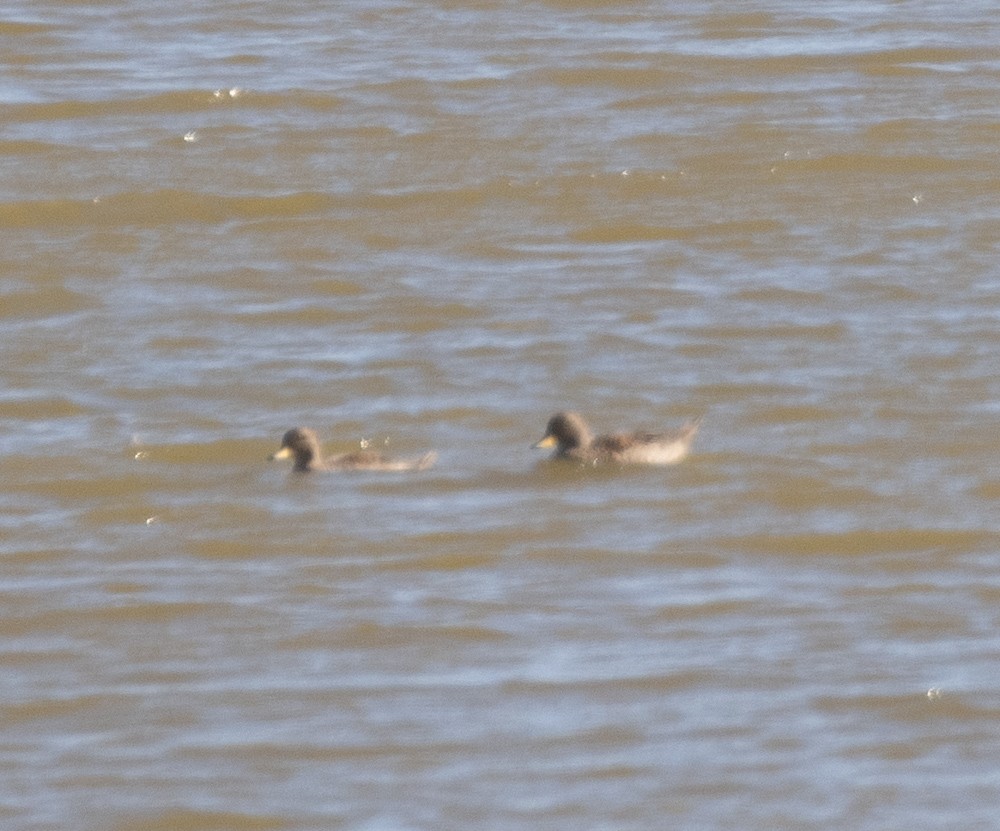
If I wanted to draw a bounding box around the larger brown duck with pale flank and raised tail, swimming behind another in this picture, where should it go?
[534,411,701,465]
